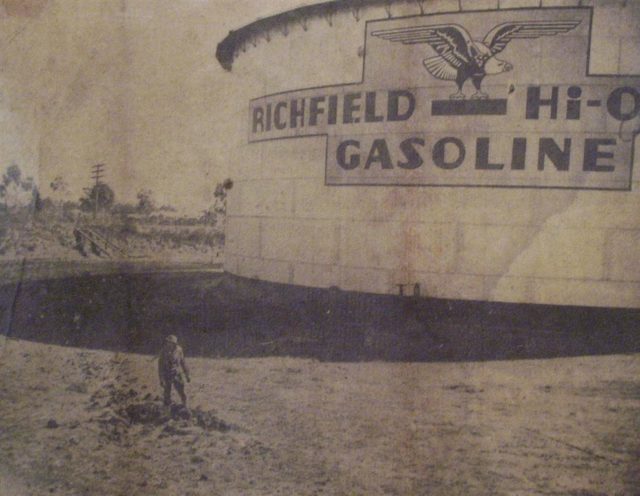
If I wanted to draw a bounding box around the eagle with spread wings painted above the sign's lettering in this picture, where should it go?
[371,20,581,100]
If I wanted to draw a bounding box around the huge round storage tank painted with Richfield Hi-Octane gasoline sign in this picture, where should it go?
[217,0,640,308]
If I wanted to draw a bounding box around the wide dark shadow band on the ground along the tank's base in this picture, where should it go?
[0,271,640,361]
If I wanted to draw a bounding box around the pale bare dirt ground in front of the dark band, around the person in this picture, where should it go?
[0,338,640,496]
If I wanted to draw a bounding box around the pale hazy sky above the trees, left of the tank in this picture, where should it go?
[0,0,309,213]
